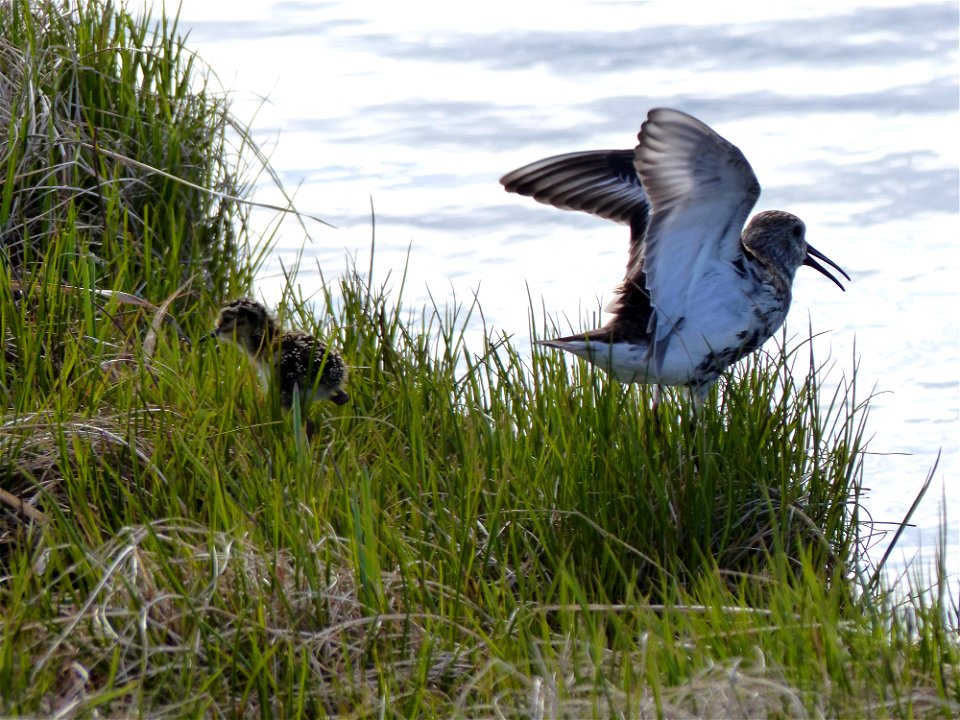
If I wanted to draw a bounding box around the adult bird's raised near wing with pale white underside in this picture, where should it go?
[628,108,760,364]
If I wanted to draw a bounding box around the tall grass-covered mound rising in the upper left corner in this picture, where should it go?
[0,0,266,298]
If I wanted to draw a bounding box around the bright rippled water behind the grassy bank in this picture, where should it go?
[139,0,960,569]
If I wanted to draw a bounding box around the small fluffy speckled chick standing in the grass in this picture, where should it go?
[206,298,350,409]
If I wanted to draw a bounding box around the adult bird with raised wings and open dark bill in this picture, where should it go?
[500,108,850,403]
